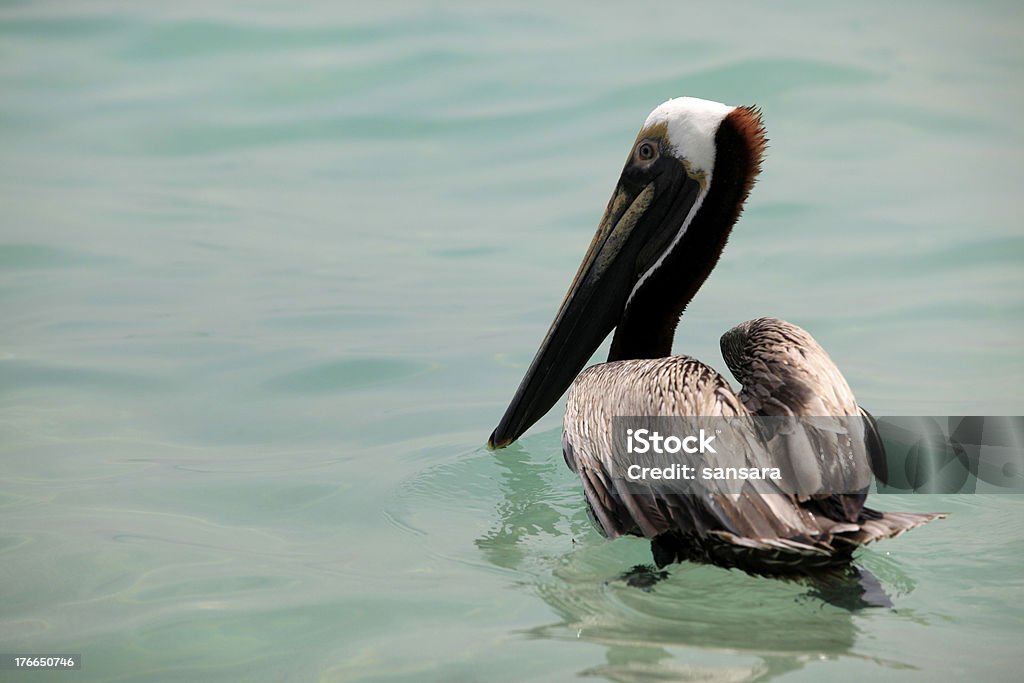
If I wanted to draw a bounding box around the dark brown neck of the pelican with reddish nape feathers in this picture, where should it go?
[608,108,766,360]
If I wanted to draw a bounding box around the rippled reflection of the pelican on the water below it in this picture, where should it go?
[475,438,912,681]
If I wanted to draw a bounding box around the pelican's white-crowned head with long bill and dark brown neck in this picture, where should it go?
[487,97,765,449]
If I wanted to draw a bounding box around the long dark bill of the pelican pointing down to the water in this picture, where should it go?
[487,166,696,449]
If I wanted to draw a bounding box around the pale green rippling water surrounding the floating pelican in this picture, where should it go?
[0,1,1024,681]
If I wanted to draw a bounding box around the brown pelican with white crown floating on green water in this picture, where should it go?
[488,97,943,573]
